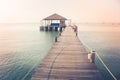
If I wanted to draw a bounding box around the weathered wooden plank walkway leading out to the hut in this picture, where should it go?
[31,27,103,80]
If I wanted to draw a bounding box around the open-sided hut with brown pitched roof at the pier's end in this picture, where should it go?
[41,13,67,31]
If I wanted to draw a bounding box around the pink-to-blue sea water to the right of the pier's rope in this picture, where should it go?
[79,25,120,80]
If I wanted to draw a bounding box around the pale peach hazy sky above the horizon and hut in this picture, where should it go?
[0,0,120,22]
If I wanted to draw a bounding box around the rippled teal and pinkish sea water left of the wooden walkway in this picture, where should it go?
[0,24,58,80]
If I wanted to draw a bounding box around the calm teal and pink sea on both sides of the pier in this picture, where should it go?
[0,24,120,80]
